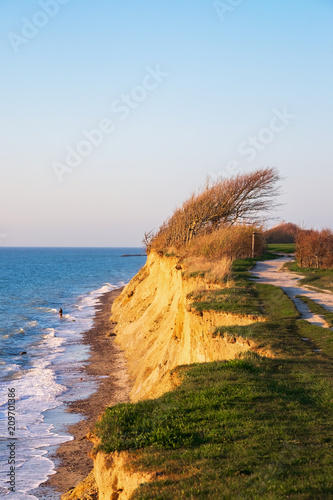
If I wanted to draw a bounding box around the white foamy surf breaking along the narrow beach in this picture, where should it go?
[0,283,129,499]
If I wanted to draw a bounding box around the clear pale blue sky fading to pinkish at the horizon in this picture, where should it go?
[0,0,333,246]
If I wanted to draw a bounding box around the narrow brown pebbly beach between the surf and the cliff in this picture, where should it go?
[34,288,130,498]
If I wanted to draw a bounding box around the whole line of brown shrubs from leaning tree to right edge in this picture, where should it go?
[144,168,333,278]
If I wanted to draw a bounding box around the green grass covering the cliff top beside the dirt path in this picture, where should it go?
[97,259,333,499]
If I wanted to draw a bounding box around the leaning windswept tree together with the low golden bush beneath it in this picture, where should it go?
[144,168,280,258]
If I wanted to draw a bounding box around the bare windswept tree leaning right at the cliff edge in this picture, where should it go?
[151,168,280,252]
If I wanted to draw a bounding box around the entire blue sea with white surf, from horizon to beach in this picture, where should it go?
[0,247,146,500]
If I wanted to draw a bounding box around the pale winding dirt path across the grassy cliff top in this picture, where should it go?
[252,256,333,328]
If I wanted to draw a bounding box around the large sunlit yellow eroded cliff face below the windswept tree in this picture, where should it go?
[111,253,268,401]
